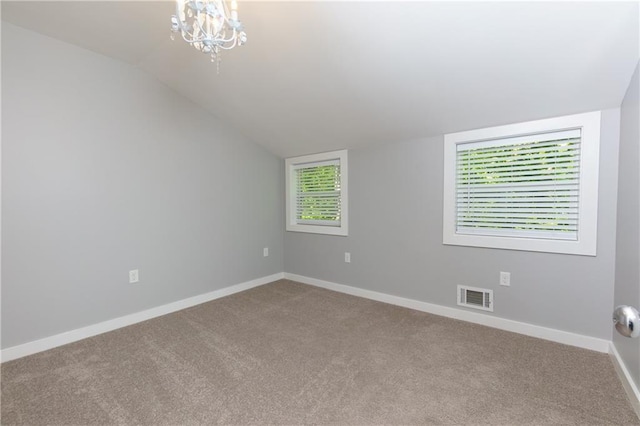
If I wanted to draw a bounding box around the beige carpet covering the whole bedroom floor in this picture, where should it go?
[1,281,640,425]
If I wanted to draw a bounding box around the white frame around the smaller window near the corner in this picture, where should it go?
[285,150,349,236]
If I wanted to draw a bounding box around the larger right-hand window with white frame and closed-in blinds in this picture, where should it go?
[443,112,600,256]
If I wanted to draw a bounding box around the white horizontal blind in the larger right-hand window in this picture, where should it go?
[455,129,581,241]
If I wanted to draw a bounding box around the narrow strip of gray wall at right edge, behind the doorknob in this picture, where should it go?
[612,60,640,387]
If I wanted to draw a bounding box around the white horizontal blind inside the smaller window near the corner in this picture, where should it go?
[293,160,341,226]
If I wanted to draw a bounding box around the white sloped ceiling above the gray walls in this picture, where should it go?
[2,0,639,157]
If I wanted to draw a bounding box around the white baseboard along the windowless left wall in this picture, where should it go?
[0,272,284,362]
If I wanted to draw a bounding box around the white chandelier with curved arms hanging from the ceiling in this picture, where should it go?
[171,0,247,67]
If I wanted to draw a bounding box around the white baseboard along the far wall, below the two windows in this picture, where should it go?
[284,272,610,353]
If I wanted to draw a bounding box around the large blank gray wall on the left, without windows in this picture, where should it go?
[2,22,284,348]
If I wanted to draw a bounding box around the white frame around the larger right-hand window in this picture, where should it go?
[442,111,601,256]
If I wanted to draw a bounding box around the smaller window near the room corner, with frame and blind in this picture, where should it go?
[285,150,348,235]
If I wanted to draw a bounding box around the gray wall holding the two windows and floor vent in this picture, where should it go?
[285,109,619,340]
